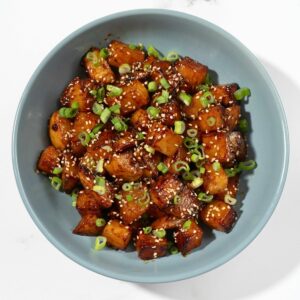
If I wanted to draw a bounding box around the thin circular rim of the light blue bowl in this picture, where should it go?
[11,9,290,283]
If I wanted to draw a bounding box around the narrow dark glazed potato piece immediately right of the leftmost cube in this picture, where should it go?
[61,153,79,193]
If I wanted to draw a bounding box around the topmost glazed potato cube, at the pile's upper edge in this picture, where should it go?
[108,41,145,67]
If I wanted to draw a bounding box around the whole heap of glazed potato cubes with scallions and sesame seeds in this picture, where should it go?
[37,40,256,260]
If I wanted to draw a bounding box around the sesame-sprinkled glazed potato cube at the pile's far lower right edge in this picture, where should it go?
[200,200,237,232]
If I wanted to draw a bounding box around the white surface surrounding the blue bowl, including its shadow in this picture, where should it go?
[0,0,300,300]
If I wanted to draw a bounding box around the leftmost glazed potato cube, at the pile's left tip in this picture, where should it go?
[37,146,61,175]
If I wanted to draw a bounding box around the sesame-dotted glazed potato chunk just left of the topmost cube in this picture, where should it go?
[82,48,115,84]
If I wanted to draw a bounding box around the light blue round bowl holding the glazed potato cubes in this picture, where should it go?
[12,10,289,282]
